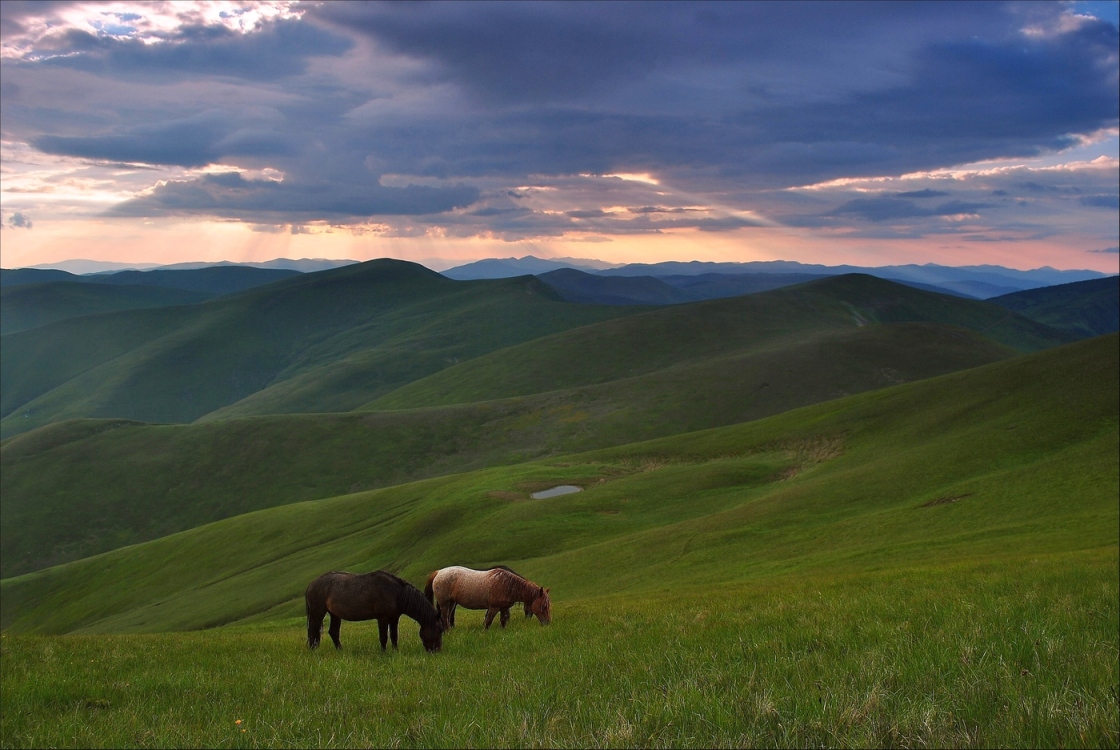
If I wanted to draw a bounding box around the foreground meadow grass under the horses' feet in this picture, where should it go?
[0,550,1120,748]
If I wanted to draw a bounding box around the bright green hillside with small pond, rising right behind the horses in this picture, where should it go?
[0,335,1120,632]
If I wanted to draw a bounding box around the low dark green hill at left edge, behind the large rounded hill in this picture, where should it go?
[0,281,214,334]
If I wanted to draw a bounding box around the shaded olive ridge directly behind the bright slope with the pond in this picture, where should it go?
[0,324,1011,575]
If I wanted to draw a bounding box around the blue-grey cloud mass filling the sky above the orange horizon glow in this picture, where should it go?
[0,2,1120,242]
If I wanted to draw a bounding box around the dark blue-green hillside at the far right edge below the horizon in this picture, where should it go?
[989,276,1120,338]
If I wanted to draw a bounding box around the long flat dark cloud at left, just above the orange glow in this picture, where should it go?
[108,172,478,221]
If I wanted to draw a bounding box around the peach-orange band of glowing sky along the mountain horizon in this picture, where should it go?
[0,219,1120,273]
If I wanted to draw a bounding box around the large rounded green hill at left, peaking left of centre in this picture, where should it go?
[2,261,624,437]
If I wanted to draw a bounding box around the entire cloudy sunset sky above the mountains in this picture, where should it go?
[0,0,1120,271]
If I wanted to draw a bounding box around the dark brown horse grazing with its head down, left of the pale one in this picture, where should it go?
[304,570,444,651]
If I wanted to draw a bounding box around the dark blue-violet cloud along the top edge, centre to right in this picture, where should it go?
[309,2,1007,103]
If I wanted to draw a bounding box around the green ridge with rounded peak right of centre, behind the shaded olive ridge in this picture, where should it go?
[365,274,1064,410]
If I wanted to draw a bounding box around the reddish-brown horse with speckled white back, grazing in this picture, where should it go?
[423,565,552,630]
